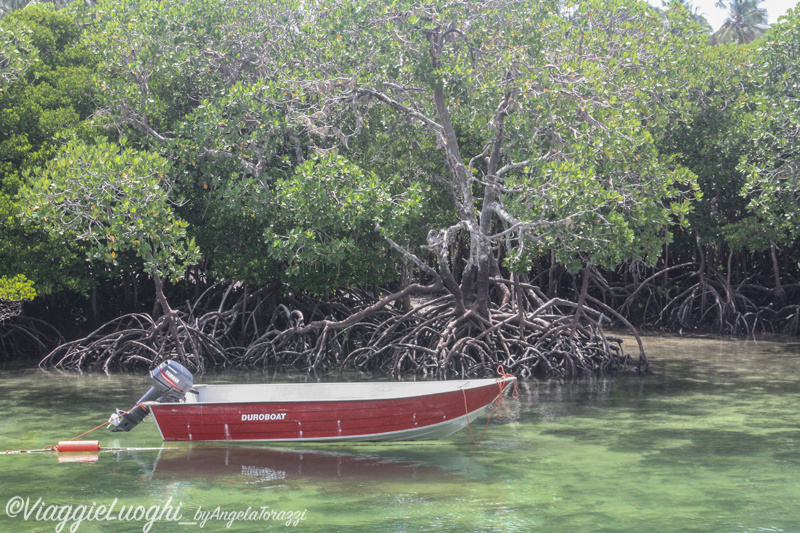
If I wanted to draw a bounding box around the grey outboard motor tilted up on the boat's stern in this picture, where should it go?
[108,360,194,431]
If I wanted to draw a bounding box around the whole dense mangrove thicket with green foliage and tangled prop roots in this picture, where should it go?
[0,0,800,374]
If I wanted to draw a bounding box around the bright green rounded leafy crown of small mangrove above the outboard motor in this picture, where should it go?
[20,138,199,278]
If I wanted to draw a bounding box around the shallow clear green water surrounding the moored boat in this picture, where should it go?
[0,338,800,532]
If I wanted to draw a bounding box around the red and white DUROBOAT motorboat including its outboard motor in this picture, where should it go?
[111,361,516,442]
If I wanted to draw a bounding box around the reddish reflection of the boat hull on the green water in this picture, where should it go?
[143,446,475,482]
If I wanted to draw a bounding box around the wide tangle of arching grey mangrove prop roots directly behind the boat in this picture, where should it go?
[36,281,644,377]
